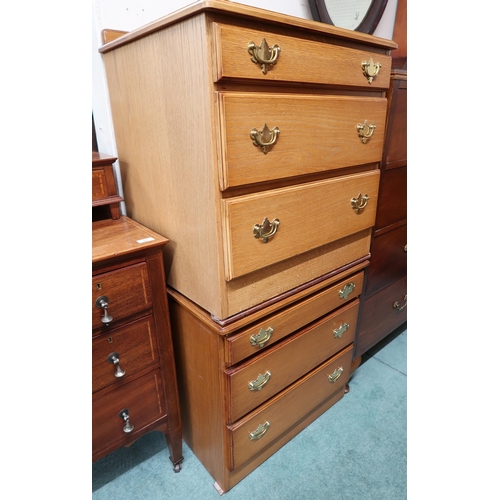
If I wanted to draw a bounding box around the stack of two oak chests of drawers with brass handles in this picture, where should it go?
[96,1,395,492]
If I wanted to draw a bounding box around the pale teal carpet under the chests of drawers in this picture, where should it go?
[92,323,407,500]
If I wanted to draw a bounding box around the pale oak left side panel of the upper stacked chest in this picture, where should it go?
[103,15,223,316]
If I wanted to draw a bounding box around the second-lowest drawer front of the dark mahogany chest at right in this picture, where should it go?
[365,224,407,296]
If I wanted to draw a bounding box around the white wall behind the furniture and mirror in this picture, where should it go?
[92,0,397,213]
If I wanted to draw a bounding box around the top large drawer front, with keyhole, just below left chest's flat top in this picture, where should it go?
[92,262,152,328]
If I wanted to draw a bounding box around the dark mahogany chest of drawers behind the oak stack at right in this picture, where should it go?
[355,70,407,358]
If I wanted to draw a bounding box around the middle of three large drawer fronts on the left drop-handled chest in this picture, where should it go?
[92,316,158,392]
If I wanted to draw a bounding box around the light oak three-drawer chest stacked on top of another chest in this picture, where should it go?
[100,1,396,319]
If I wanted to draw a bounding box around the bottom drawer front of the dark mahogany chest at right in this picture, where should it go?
[356,277,407,357]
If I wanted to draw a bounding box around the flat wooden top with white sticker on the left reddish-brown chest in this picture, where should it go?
[92,215,169,264]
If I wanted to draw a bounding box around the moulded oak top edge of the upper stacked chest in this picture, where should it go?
[99,0,398,53]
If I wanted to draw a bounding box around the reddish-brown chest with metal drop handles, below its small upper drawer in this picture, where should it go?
[92,216,182,472]
